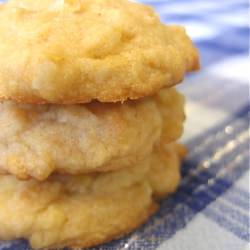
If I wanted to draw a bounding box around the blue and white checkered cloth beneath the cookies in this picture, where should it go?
[0,0,250,250]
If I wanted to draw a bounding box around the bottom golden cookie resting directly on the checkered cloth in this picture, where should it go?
[0,144,180,249]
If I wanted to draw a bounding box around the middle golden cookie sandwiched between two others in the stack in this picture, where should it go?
[0,89,184,180]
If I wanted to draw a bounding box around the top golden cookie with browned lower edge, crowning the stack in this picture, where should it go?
[0,0,199,104]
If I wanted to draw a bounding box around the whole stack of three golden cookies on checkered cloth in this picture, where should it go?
[0,0,199,249]
